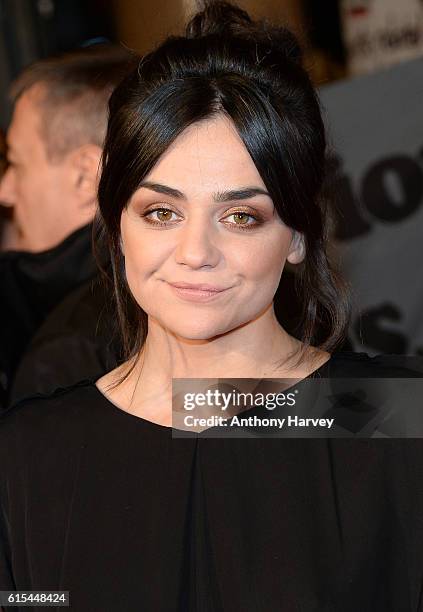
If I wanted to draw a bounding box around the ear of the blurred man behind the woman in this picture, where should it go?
[70,144,101,209]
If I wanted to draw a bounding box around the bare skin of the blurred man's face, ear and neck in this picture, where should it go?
[0,84,101,252]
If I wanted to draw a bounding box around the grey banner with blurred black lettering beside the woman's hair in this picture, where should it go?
[320,58,423,355]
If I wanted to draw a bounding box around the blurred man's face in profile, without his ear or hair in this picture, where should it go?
[0,85,76,251]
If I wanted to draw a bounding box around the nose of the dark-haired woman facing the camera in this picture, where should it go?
[175,218,220,269]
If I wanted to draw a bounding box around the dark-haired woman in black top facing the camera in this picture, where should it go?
[0,2,423,612]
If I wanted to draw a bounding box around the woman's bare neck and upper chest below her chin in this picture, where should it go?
[110,304,316,425]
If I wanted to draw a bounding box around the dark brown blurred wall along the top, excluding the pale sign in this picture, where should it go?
[0,0,345,129]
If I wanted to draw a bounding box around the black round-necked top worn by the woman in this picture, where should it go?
[0,353,423,612]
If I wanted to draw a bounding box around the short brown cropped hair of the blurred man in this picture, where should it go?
[10,44,135,161]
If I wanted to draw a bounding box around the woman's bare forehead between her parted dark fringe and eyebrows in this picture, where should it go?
[146,115,264,189]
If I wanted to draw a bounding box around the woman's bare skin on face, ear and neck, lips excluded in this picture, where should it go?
[97,115,330,426]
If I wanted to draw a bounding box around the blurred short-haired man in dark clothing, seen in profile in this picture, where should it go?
[0,45,133,407]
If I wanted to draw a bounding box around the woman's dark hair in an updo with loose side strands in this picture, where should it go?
[99,1,348,358]
